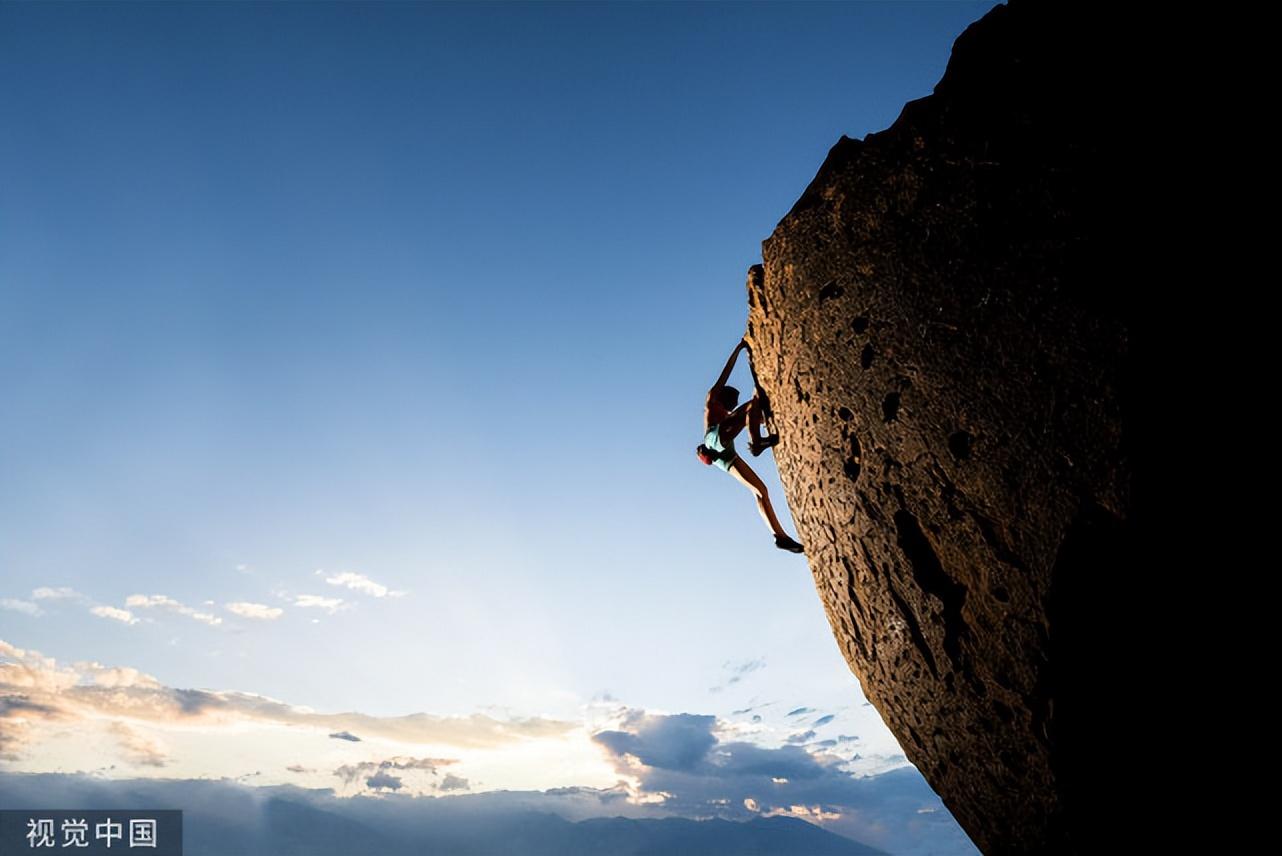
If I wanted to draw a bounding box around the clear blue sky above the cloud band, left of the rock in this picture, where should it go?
[0,3,995,850]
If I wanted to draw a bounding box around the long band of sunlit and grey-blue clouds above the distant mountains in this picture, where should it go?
[0,641,959,852]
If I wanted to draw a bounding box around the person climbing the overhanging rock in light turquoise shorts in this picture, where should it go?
[695,340,803,552]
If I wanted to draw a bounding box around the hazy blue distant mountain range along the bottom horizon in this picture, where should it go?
[0,773,885,856]
